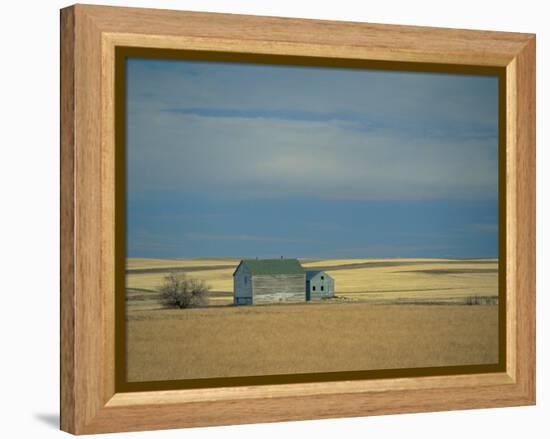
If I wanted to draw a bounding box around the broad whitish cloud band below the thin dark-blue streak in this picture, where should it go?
[128,113,497,199]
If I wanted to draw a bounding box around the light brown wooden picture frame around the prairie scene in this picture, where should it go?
[61,5,535,434]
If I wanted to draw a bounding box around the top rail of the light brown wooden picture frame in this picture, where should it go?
[78,5,528,66]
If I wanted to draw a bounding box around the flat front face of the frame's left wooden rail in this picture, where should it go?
[74,9,102,431]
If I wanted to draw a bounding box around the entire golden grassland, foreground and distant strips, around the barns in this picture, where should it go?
[126,258,498,382]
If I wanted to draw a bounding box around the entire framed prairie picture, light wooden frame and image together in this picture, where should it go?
[61,5,535,434]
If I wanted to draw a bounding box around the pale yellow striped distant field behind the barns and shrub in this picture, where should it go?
[127,258,498,311]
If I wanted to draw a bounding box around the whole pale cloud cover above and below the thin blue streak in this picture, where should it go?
[127,58,498,199]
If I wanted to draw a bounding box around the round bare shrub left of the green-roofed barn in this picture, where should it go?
[159,272,210,309]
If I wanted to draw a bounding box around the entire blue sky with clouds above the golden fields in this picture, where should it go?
[127,58,498,258]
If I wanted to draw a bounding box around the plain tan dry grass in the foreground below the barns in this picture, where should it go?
[127,303,498,382]
